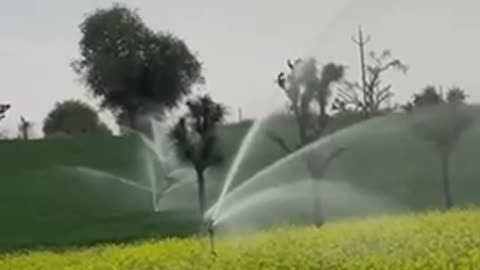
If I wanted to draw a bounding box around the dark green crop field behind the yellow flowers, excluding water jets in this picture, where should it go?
[0,110,480,251]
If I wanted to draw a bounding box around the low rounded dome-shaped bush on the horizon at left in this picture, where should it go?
[43,100,111,136]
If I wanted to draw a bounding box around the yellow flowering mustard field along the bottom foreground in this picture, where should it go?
[0,209,480,270]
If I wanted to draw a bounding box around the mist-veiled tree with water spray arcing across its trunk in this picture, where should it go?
[268,58,344,226]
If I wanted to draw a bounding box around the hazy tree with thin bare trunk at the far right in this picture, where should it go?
[410,86,474,209]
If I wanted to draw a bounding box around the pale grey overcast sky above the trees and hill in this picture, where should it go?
[0,0,480,135]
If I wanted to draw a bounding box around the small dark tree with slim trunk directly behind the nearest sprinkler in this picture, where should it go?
[170,95,226,216]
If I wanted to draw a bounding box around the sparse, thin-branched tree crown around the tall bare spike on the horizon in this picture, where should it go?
[334,50,408,118]
